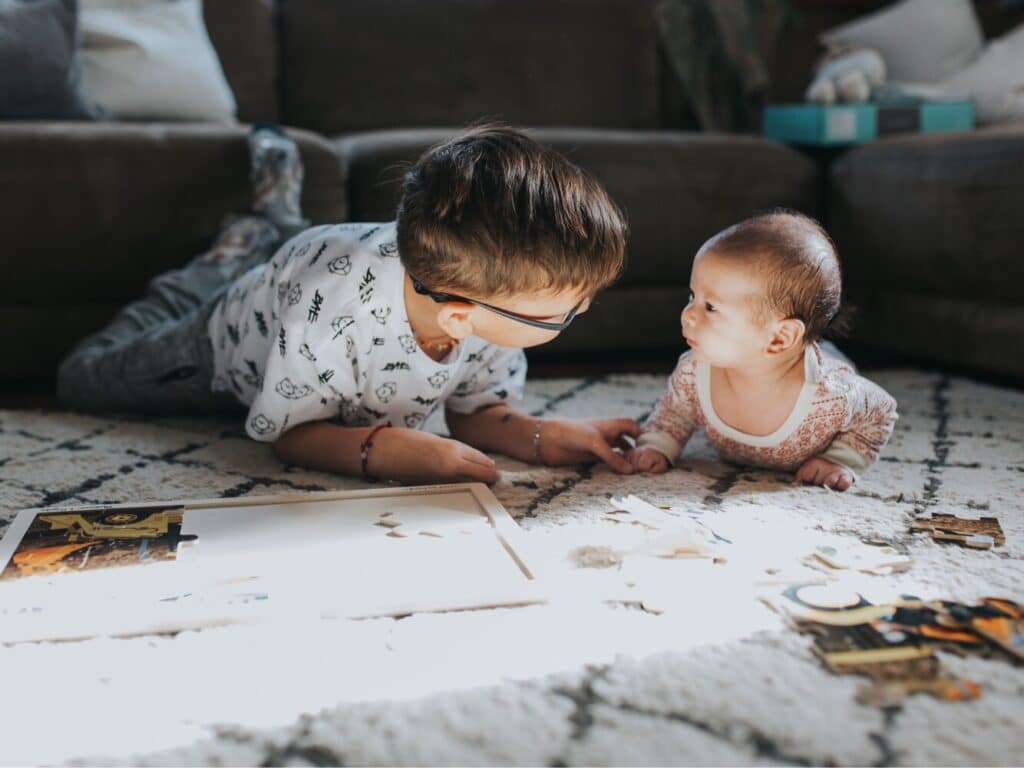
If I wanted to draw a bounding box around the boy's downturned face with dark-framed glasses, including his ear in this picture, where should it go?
[437,289,590,347]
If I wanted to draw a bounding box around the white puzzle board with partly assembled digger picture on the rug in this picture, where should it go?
[0,483,543,643]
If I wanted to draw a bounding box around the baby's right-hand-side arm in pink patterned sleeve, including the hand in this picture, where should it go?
[797,376,898,490]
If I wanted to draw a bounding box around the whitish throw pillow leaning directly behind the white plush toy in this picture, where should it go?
[821,0,984,83]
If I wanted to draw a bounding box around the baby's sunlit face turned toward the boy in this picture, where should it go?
[682,251,771,368]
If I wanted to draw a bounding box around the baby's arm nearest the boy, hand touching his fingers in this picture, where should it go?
[627,352,698,474]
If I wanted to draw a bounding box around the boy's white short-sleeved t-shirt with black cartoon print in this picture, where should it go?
[208,223,526,441]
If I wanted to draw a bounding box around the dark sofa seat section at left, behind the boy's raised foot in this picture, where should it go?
[0,123,345,385]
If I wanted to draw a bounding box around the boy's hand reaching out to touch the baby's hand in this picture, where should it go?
[540,419,640,475]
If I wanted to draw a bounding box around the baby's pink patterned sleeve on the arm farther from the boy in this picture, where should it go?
[821,374,899,474]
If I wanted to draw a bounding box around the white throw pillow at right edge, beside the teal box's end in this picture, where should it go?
[942,25,1024,125]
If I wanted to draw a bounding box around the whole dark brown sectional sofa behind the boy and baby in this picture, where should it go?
[0,0,1024,388]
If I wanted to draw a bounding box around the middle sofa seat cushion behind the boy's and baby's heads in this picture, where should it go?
[337,128,818,288]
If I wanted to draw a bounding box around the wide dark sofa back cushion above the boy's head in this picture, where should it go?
[281,0,658,134]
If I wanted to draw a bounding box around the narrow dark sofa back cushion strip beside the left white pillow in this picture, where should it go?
[203,0,281,123]
